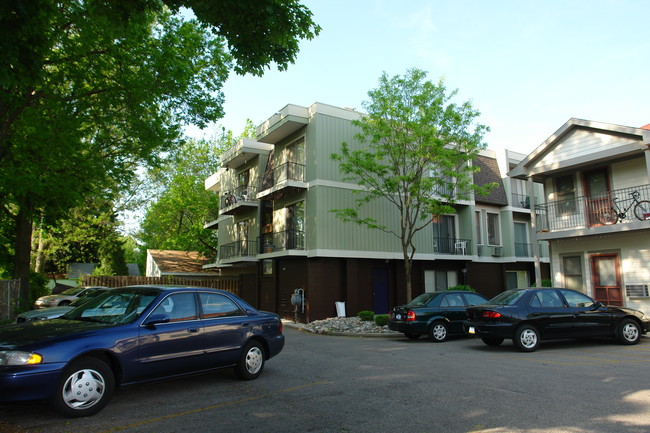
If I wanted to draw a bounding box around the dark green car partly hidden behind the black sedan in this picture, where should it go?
[388,290,488,342]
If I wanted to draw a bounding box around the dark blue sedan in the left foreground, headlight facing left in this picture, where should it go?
[0,286,284,417]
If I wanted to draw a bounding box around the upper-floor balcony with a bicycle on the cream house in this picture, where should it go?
[535,185,650,238]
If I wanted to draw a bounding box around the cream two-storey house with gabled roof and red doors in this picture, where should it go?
[510,119,650,311]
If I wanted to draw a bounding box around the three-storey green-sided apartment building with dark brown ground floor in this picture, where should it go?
[205,103,550,322]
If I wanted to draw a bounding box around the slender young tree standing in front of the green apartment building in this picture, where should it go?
[332,69,491,300]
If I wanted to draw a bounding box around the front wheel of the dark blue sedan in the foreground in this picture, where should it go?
[52,358,115,418]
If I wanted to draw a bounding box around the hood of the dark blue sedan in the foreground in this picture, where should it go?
[0,319,115,349]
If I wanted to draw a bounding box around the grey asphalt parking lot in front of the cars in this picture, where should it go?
[0,327,650,433]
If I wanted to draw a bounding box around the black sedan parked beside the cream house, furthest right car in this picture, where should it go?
[464,288,650,352]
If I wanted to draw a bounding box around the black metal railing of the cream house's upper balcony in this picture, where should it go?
[535,185,650,232]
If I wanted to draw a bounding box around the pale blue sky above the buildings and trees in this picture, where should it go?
[188,0,650,154]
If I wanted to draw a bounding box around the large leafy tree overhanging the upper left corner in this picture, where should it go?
[0,0,320,299]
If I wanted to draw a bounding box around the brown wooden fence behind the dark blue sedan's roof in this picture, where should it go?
[81,275,241,296]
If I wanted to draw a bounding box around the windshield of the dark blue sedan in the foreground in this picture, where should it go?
[63,287,161,325]
